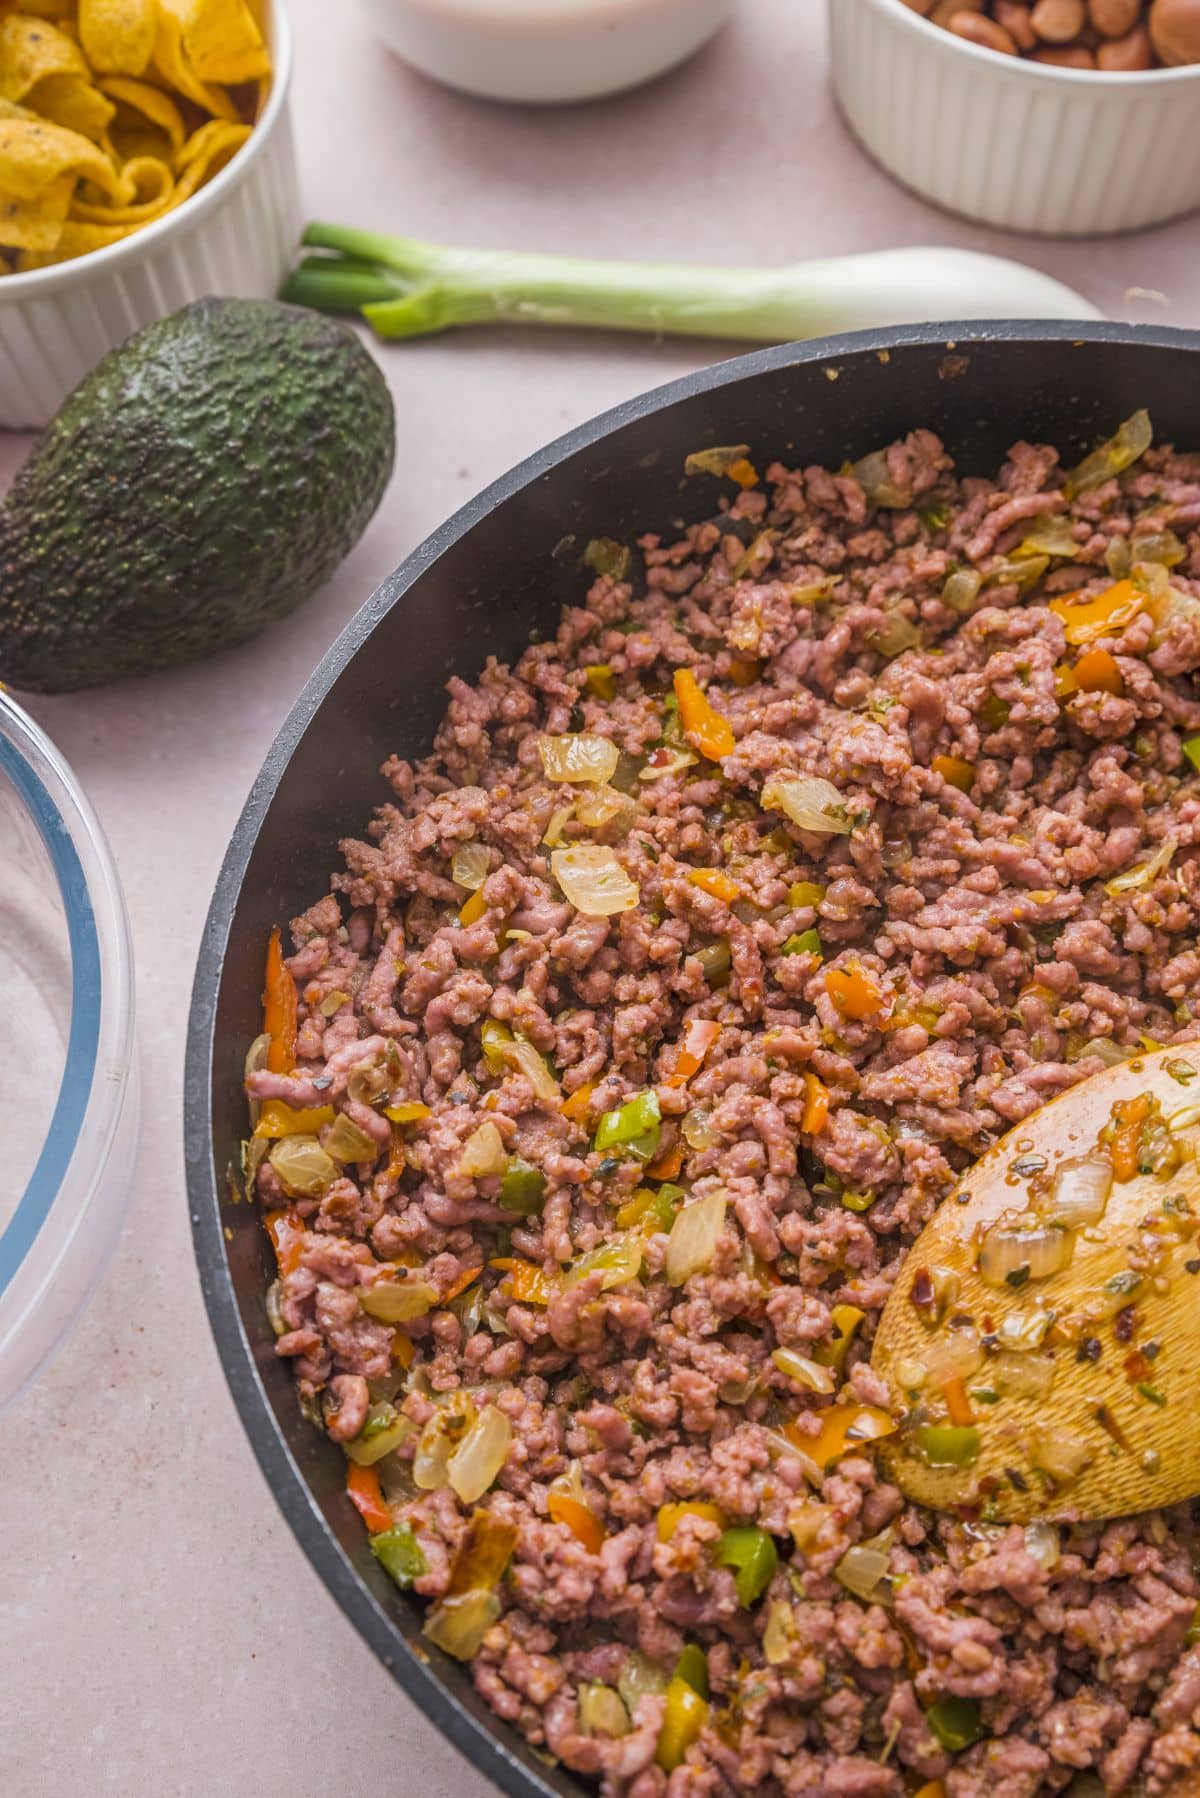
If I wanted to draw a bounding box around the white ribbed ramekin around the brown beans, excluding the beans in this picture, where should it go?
[829,0,1200,237]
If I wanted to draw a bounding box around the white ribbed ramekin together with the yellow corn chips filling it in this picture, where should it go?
[0,0,299,430]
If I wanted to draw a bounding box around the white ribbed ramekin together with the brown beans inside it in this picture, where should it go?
[829,0,1200,237]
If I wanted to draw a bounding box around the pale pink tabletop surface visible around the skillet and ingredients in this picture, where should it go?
[0,0,1200,1798]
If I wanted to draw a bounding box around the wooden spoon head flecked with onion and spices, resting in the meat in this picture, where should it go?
[873,1043,1200,1523]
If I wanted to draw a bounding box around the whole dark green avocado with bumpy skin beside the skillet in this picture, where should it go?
[0,300,396,692]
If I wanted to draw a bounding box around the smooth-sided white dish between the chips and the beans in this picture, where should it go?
[369,0,732,106]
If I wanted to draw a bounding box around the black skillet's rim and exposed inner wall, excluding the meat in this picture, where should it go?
[185,324,1200,1798]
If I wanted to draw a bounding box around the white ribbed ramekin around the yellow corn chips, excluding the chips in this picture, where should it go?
[0,0,300,430]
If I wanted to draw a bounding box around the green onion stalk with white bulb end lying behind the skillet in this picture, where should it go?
[282,225,1099,343]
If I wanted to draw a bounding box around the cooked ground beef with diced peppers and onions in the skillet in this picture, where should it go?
[248,417,1200,1798]
